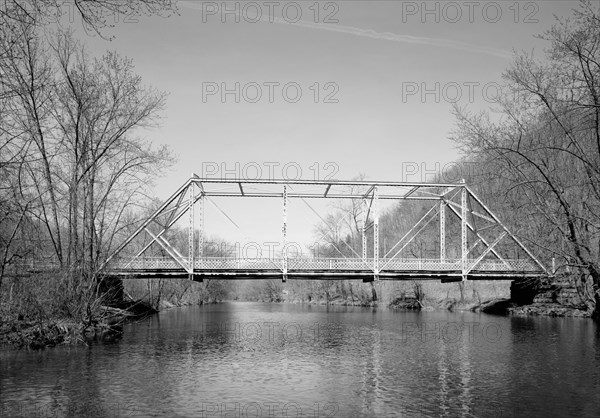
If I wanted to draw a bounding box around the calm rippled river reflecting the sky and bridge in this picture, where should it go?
[0,302,600,417]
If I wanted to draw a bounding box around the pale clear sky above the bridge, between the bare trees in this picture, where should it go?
[64,0,576,255]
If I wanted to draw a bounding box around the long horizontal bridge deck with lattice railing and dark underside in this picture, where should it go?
[106,257,545,280]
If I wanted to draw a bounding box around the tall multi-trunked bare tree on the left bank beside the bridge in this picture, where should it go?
[0,28,172,334]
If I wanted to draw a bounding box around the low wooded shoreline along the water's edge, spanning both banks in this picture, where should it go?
[0,276,592,350]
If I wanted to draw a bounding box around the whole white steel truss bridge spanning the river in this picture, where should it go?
[100,175,548,282]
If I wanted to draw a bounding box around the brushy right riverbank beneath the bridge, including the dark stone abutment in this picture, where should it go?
[276,276,593,318]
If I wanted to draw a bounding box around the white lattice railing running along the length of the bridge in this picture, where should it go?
[108,257,540,272]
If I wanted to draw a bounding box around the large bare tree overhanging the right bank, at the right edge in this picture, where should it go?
[453,0,600,314]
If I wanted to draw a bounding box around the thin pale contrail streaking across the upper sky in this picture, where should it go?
[178,1,512,58]
